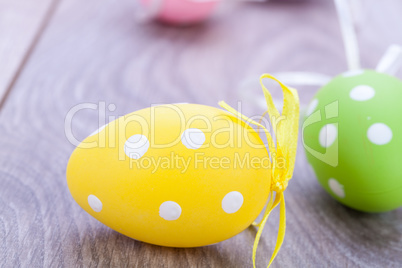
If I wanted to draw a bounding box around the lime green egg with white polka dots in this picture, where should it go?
[303,70,402,212]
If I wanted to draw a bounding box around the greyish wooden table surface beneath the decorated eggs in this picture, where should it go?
[0,0,402,267]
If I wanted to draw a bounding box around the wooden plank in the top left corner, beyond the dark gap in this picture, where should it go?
[0,0,57,107]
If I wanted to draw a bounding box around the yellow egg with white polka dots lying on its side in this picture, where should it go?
[67,104,271,247]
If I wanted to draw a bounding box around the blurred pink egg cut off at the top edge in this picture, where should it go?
[141,0,218,25]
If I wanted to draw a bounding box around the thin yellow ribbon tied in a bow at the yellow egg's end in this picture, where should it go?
[219,74,299,268]
